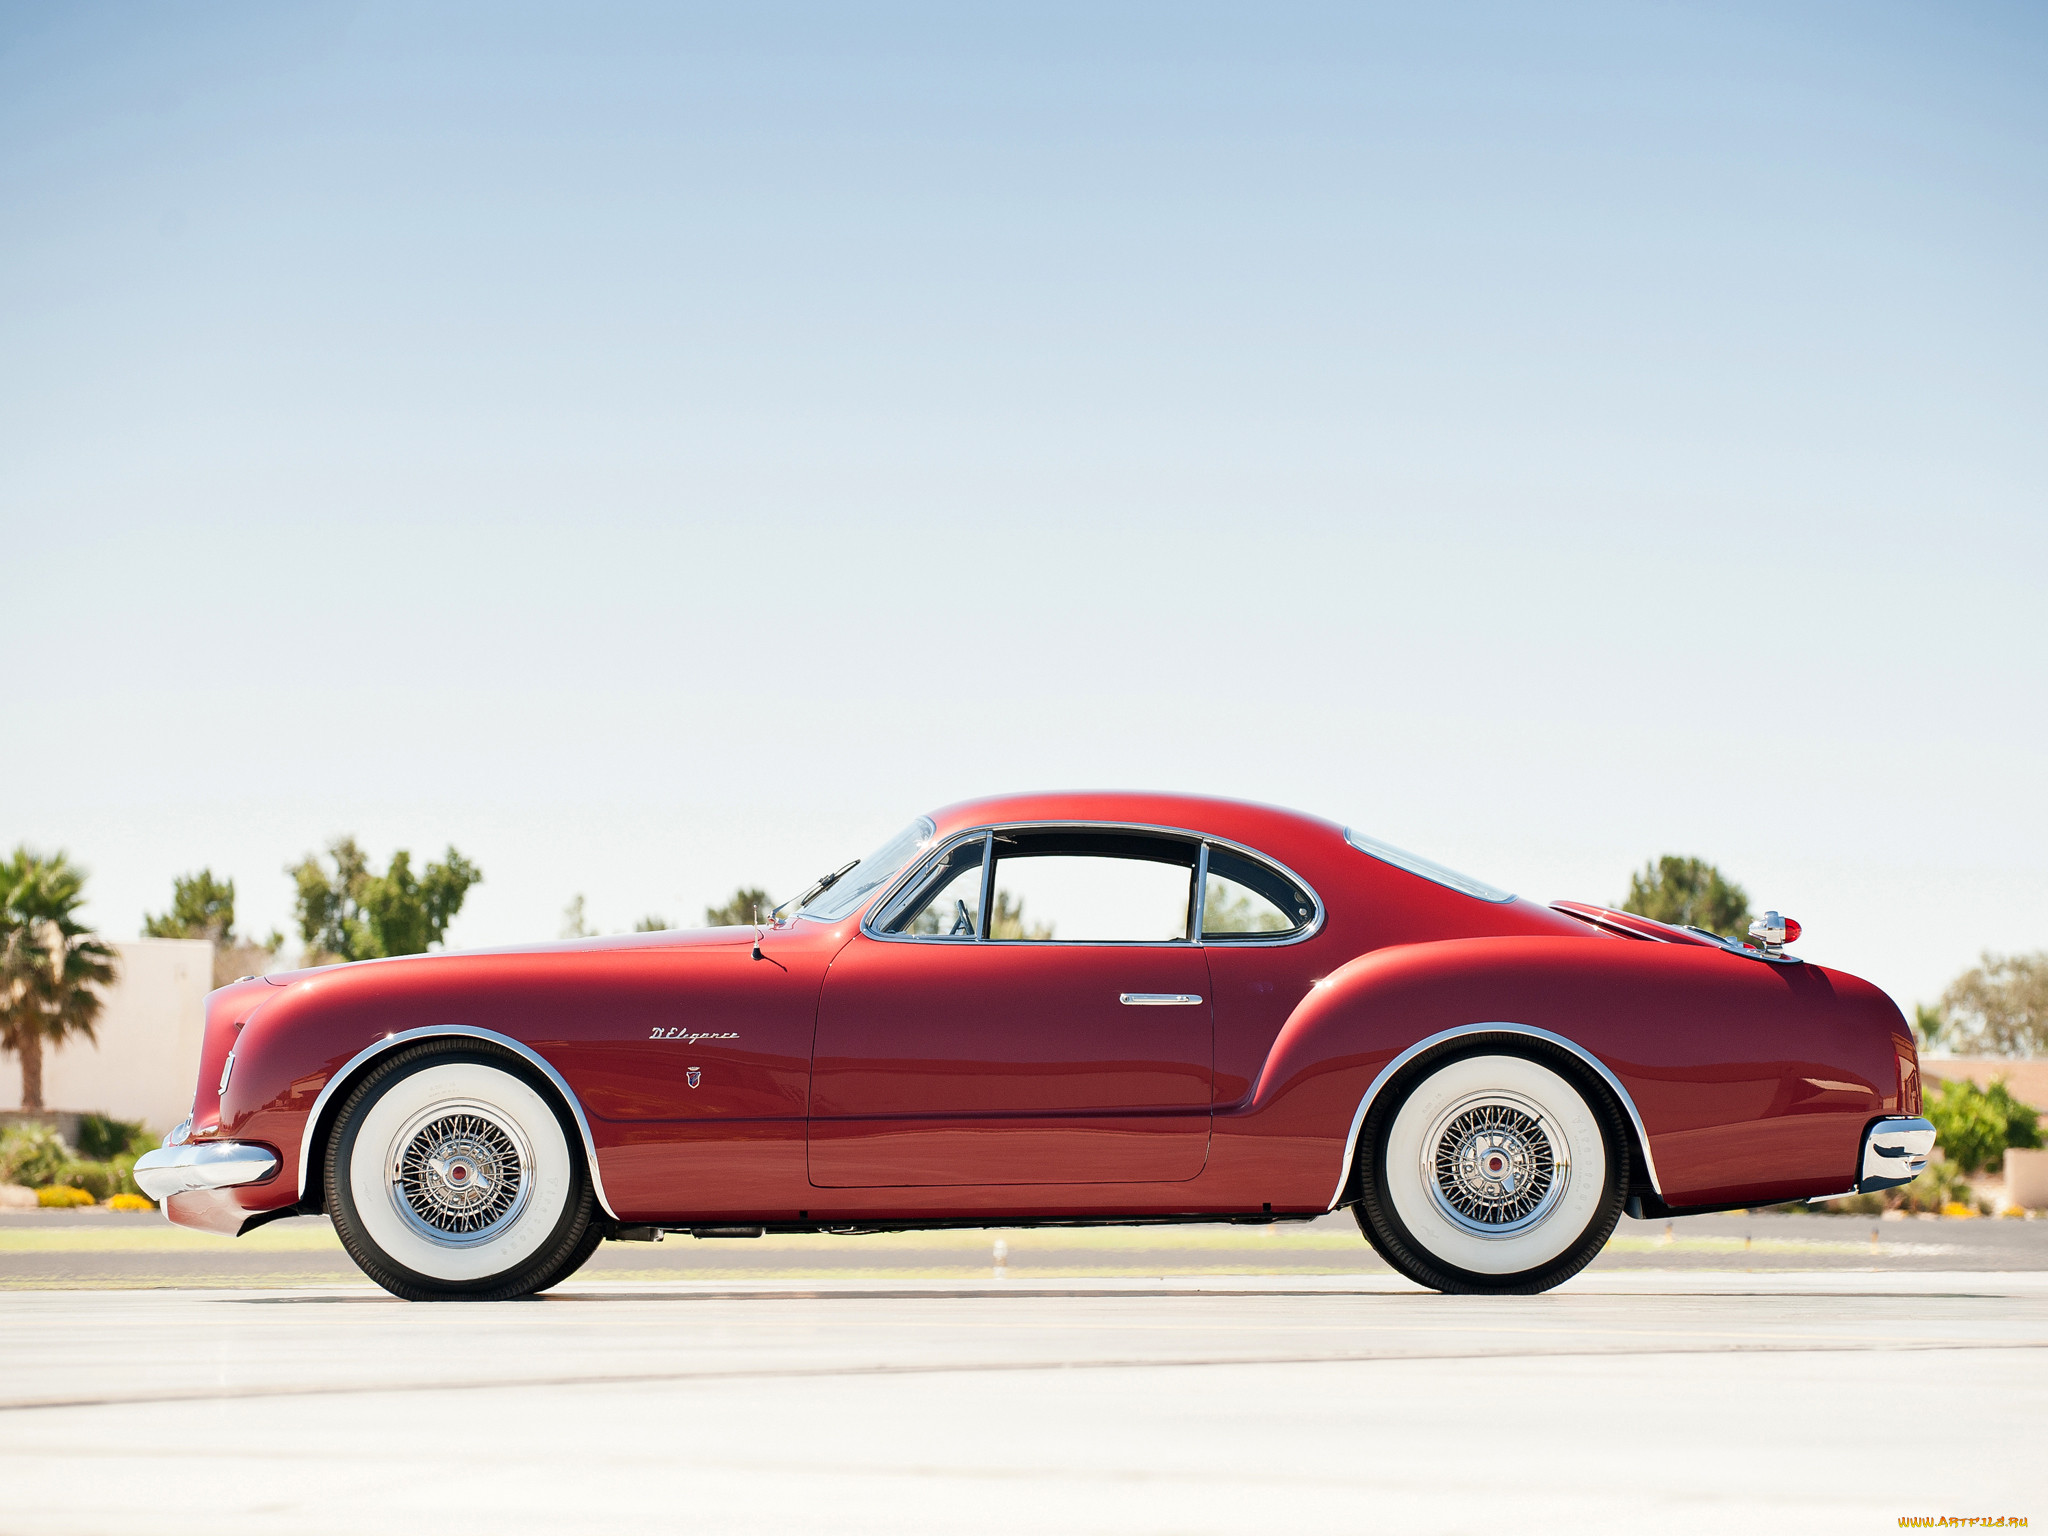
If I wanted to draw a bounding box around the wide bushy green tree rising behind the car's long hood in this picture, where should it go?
[285,838,483,965]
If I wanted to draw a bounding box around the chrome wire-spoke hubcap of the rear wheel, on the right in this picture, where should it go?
[1421,1094,1571,1237]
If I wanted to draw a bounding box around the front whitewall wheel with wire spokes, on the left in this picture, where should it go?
[326,1044,604,1300]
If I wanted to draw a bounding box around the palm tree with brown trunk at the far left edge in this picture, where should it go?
[0,848,115,1110]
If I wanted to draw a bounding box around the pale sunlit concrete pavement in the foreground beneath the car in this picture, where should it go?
[0,1270,2048,1536]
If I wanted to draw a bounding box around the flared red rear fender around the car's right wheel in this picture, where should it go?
[1243,938,1913,1206]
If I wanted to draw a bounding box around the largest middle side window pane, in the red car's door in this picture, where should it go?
[989,827,1196,944]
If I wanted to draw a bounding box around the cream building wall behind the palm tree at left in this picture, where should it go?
[0,938,213,1133]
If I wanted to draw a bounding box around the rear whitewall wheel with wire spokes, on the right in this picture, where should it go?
[1356,1055,1628,1294]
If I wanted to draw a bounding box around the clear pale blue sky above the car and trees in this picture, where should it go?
[0,4,2048,1024]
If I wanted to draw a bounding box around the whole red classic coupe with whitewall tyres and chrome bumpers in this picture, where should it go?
[135,795,1933,1300]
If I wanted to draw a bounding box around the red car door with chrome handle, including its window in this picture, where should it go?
[809,827,1214,1188]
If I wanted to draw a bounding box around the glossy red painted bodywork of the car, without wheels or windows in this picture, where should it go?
[170,793,1919,1231]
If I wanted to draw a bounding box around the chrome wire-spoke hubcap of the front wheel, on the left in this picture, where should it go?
[391,1104,532,1245]
